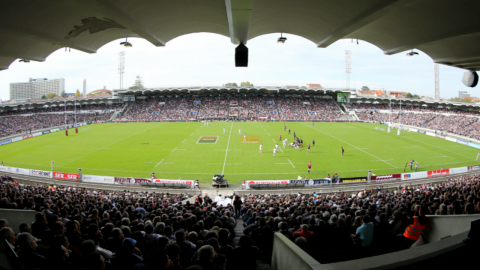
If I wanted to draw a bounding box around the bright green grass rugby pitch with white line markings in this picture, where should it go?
[0,122,479,183]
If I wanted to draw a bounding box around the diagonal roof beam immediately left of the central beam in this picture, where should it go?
[91,0,165,47]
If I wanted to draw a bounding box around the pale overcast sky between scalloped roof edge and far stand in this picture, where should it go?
[0,33,472,100]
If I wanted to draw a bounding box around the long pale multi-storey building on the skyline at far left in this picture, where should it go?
[10,78,65,99]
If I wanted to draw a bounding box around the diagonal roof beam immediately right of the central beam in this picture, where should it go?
[317,0,419,48]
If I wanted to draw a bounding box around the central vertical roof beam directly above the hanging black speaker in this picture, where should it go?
[225,0,253,44]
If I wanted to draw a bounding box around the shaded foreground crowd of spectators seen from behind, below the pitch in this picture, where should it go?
[0,175,480,270]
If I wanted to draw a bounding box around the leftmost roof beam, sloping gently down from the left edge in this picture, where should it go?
[0,24,97,54]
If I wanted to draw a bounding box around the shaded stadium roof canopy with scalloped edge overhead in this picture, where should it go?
[0,0,480,70]
